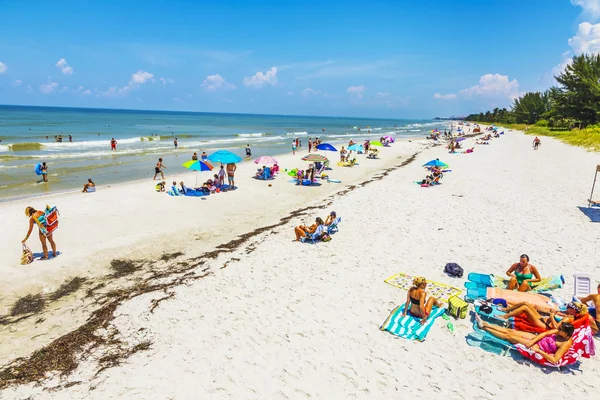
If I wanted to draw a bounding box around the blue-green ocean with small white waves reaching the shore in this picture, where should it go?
[0,106,449,199]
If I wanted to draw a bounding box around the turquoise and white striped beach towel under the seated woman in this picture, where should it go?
[379,304,446,342]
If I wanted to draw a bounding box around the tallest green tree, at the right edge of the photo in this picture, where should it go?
[550,54,600,126]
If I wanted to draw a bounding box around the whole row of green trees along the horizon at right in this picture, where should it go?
[465,54,600,129]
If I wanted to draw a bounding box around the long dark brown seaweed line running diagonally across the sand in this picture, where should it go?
[0,152,420,390]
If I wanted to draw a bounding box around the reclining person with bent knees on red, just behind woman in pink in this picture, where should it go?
[498,302,588,333]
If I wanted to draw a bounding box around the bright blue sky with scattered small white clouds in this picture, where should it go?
[0,0,600,118]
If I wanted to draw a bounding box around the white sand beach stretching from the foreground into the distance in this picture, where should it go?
[0,132,600,400]
